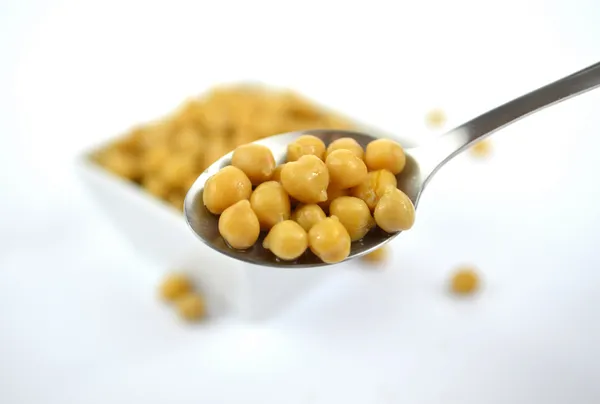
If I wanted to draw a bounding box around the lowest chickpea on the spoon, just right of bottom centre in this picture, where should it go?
[308,216,351,264]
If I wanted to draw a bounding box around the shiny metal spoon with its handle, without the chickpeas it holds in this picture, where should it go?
[184,63,600,269]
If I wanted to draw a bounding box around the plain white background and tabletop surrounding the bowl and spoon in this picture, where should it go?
[0,0,600,404]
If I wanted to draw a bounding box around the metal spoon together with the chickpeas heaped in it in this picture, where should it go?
[184,63,600,267]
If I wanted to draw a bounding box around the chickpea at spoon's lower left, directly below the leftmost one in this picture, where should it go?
[219,199,260,250]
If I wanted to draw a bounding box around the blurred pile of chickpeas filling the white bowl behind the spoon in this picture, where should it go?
[94,85,353,210]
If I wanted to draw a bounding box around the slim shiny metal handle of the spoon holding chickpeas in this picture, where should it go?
[414,62,600,178]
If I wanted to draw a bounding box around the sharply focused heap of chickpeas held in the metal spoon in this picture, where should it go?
[203,135,415,264]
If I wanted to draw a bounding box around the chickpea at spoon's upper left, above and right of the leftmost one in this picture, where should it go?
[231,143,276,185]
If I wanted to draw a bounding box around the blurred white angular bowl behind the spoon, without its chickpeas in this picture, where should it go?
[77,96,408,319]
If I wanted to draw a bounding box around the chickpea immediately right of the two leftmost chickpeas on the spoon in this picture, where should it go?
[250,181,291,230]
